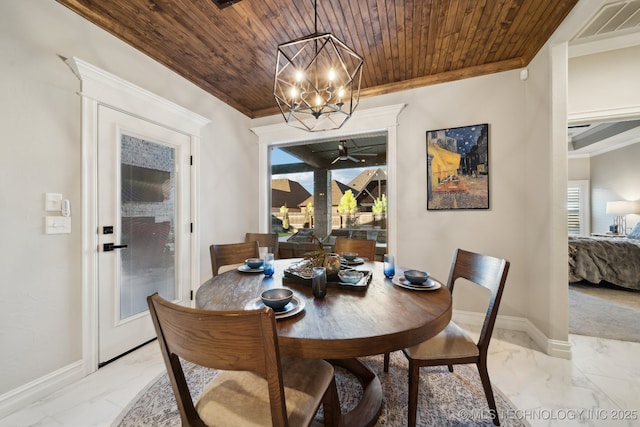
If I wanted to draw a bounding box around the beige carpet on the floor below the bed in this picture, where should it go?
[569,283,640,342]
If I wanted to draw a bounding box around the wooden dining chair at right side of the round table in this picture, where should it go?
[396,249,509,426]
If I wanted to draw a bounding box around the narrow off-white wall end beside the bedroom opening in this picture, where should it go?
[524,43,568,341]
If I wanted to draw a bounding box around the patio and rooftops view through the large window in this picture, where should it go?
[271,133,387,259]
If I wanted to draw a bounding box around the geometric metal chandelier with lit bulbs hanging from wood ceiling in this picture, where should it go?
[273,0,364,132]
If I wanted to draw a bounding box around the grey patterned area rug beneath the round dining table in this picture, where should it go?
[112,352,529,427]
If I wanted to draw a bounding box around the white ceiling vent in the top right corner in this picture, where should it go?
[575,0,640,40]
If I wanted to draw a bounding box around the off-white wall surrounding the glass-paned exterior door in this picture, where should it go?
[0,0,258,400]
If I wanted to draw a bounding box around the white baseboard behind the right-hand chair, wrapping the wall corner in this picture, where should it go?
[453,310,571,360]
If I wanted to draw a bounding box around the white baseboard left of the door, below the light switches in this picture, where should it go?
[0,360,85,419]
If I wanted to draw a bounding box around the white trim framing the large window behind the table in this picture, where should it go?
[251,104,406,253]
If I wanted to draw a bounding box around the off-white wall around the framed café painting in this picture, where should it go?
[362,71,526,316]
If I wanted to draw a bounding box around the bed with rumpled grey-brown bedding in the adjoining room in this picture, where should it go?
[569,231,640,290]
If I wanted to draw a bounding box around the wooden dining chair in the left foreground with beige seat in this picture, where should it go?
[147,293,341,426]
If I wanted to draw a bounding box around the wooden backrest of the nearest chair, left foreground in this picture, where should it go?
[147,293,287,425]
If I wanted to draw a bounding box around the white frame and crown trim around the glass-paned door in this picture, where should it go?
[66,57,210,375]
